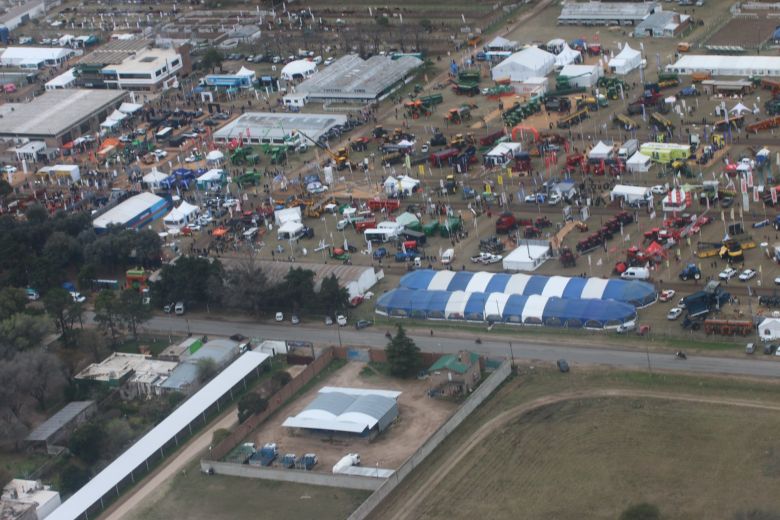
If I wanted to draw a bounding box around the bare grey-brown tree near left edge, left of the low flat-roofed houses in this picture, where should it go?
[14,349,67,410]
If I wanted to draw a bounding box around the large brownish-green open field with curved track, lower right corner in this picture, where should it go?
[374,368,780,519]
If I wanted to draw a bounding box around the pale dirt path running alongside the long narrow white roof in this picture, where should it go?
[101,406,238,520]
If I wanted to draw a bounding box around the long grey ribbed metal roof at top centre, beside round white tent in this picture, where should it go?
[296,54,422,99]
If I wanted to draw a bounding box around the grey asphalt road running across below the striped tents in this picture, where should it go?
[116,310,780,378]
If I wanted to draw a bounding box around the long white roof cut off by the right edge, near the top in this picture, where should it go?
[666,54,780,76]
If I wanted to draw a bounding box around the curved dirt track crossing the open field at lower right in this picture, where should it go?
[372,389,780,520]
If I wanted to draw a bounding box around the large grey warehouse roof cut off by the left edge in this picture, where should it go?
[0,89,127,137]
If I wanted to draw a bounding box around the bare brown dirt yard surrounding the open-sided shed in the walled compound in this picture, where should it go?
[251,362,458,473]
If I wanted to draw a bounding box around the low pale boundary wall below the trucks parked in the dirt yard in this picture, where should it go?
[200,460,385,491]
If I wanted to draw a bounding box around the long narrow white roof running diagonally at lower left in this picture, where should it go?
[46,352,270,520]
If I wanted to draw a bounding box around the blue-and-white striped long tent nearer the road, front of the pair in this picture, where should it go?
[376,288,636,329]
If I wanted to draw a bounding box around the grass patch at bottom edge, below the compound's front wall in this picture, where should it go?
[128,464,368,520]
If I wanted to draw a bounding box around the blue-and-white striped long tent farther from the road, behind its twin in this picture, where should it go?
[400,269,658,307]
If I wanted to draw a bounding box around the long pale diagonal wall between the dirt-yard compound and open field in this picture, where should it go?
[348,361,511,520]
